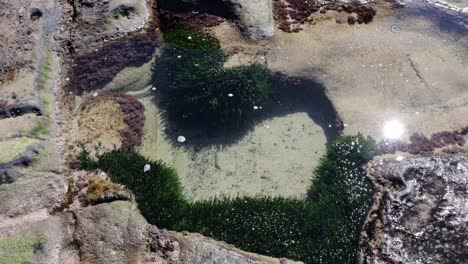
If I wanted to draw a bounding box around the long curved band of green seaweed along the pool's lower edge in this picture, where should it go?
[80,134,376,263]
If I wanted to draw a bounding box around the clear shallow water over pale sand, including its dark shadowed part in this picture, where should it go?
[148,1,467,200]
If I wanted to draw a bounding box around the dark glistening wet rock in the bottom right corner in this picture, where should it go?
[360,156,468,263]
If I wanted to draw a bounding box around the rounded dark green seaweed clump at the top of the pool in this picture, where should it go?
[156,25,271,127]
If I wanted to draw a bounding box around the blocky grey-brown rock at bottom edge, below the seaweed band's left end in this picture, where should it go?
[74,201,148,264]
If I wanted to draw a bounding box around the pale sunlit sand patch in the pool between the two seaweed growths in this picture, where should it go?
[139,95,327,199]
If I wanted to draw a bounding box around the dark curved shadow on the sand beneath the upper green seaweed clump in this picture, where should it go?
[154,74,340,149]
